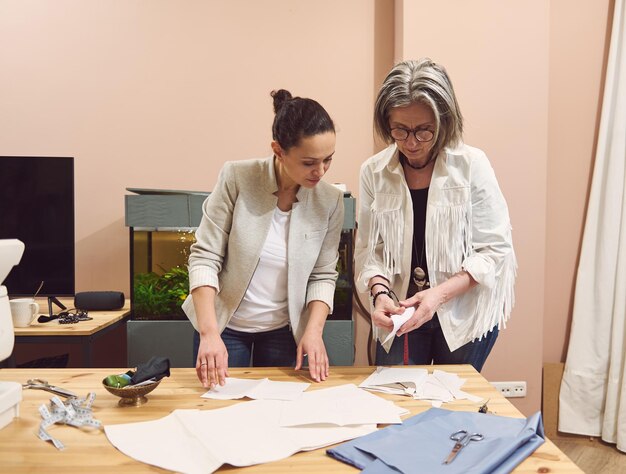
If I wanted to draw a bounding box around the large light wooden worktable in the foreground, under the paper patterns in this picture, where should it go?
[0,365,582,474]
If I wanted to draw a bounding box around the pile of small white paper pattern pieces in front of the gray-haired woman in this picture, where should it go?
[359,367,482,407]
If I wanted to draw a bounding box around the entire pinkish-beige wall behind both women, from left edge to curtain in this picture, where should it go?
[0,0,612,413]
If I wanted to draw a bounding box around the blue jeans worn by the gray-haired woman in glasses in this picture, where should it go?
[376,315,498,372]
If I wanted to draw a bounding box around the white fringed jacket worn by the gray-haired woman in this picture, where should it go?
[355,144,517,351]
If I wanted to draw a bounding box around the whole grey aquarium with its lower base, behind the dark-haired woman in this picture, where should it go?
[124,188,356,367]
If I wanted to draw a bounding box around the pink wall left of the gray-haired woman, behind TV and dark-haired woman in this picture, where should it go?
[0,0,375,291]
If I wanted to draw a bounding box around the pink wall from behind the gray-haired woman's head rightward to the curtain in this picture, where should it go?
[396,0,612,413]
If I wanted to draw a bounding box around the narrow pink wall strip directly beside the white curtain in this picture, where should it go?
[543,0,614,362]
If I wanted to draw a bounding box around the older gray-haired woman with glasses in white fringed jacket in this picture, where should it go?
[355,58,517,371]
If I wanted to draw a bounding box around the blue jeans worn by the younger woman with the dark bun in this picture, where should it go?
[193,326,297,367]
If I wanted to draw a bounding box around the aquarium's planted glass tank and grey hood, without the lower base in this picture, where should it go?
[125,188,355,321]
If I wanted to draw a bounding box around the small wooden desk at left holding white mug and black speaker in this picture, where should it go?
[15,300,130,367]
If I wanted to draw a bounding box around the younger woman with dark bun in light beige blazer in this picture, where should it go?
[183,89,344,387]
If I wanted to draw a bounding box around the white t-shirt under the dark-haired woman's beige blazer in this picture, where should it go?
[226,208,291,332]
